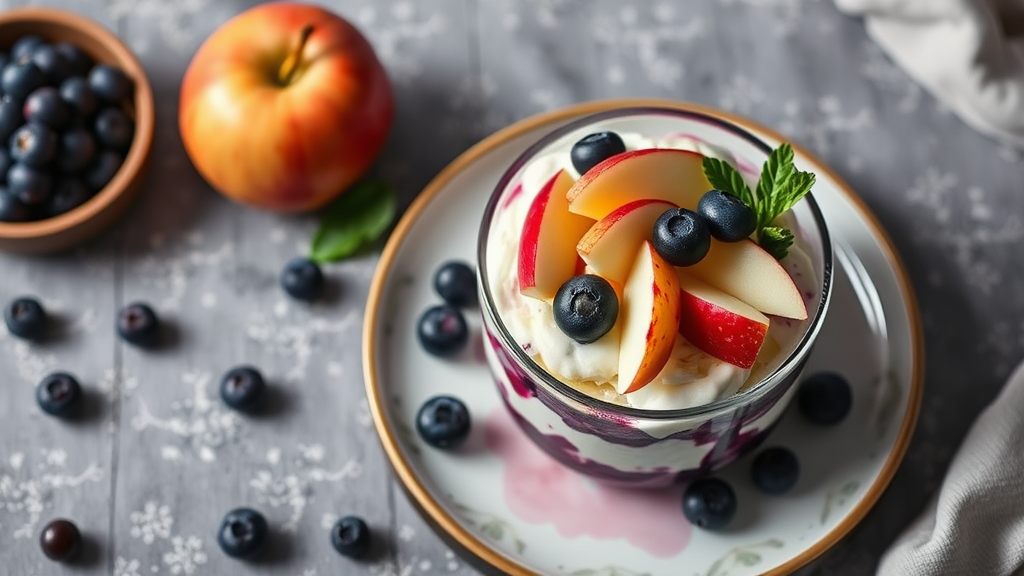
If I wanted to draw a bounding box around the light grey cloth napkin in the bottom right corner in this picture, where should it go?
[878,364,1024,576]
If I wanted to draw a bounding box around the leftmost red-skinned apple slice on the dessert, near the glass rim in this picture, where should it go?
[518,170,594,300]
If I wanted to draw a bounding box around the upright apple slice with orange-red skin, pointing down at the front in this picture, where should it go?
[615,241,679,394]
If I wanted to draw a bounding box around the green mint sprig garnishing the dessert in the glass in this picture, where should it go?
[703,143,815,260]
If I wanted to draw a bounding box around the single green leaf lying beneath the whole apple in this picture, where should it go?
[309,180,395,263]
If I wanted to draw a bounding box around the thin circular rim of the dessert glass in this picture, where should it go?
[476,106,835,420]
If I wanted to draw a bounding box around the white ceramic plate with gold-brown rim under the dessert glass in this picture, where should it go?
[364,100,924,576]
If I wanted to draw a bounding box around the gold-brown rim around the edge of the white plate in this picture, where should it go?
[362,98,925,576]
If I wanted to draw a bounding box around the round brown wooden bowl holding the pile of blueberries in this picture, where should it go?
[0,8,156,254]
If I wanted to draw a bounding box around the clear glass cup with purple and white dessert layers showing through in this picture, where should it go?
[477,108,833,487]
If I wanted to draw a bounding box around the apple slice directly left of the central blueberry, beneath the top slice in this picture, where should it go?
[577,200,678,282]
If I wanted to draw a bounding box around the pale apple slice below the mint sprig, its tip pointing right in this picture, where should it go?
[686,239,807,320]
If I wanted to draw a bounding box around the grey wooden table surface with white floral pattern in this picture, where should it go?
[0,0,1024,576]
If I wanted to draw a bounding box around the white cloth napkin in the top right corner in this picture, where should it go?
[836,0,1024,149]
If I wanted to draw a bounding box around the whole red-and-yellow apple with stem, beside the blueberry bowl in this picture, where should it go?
[178,2,393,211]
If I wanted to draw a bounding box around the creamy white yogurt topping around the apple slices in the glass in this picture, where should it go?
[487,133,813,410]
